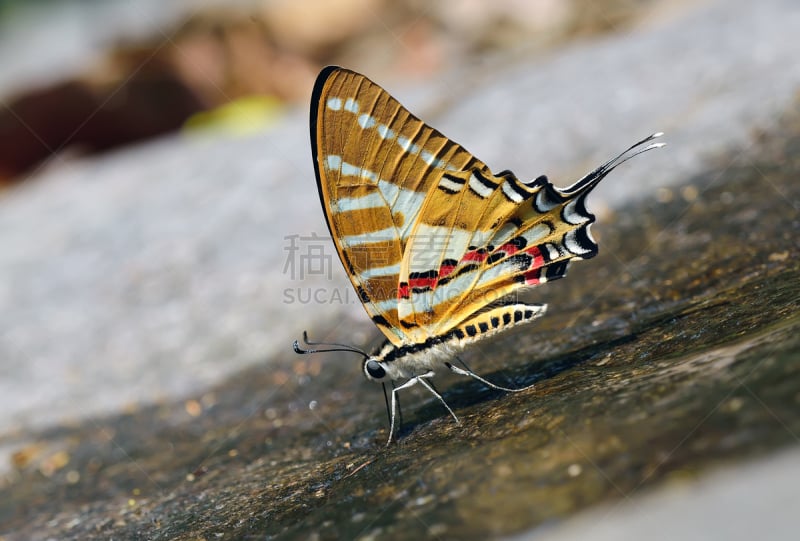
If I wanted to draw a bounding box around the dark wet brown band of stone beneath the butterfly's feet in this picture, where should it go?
[0,112,800,539]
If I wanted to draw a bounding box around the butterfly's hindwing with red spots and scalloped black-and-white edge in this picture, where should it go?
[399,165,597,335]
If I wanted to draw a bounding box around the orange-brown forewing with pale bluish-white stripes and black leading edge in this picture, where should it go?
[311,67,486,345]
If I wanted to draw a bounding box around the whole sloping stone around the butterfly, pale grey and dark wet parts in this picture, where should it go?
[0,0,800,539]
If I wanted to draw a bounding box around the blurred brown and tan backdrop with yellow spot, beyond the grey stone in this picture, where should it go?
[0,0,669,184]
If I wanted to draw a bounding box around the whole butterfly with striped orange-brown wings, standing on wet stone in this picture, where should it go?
[294,66,663,445]
